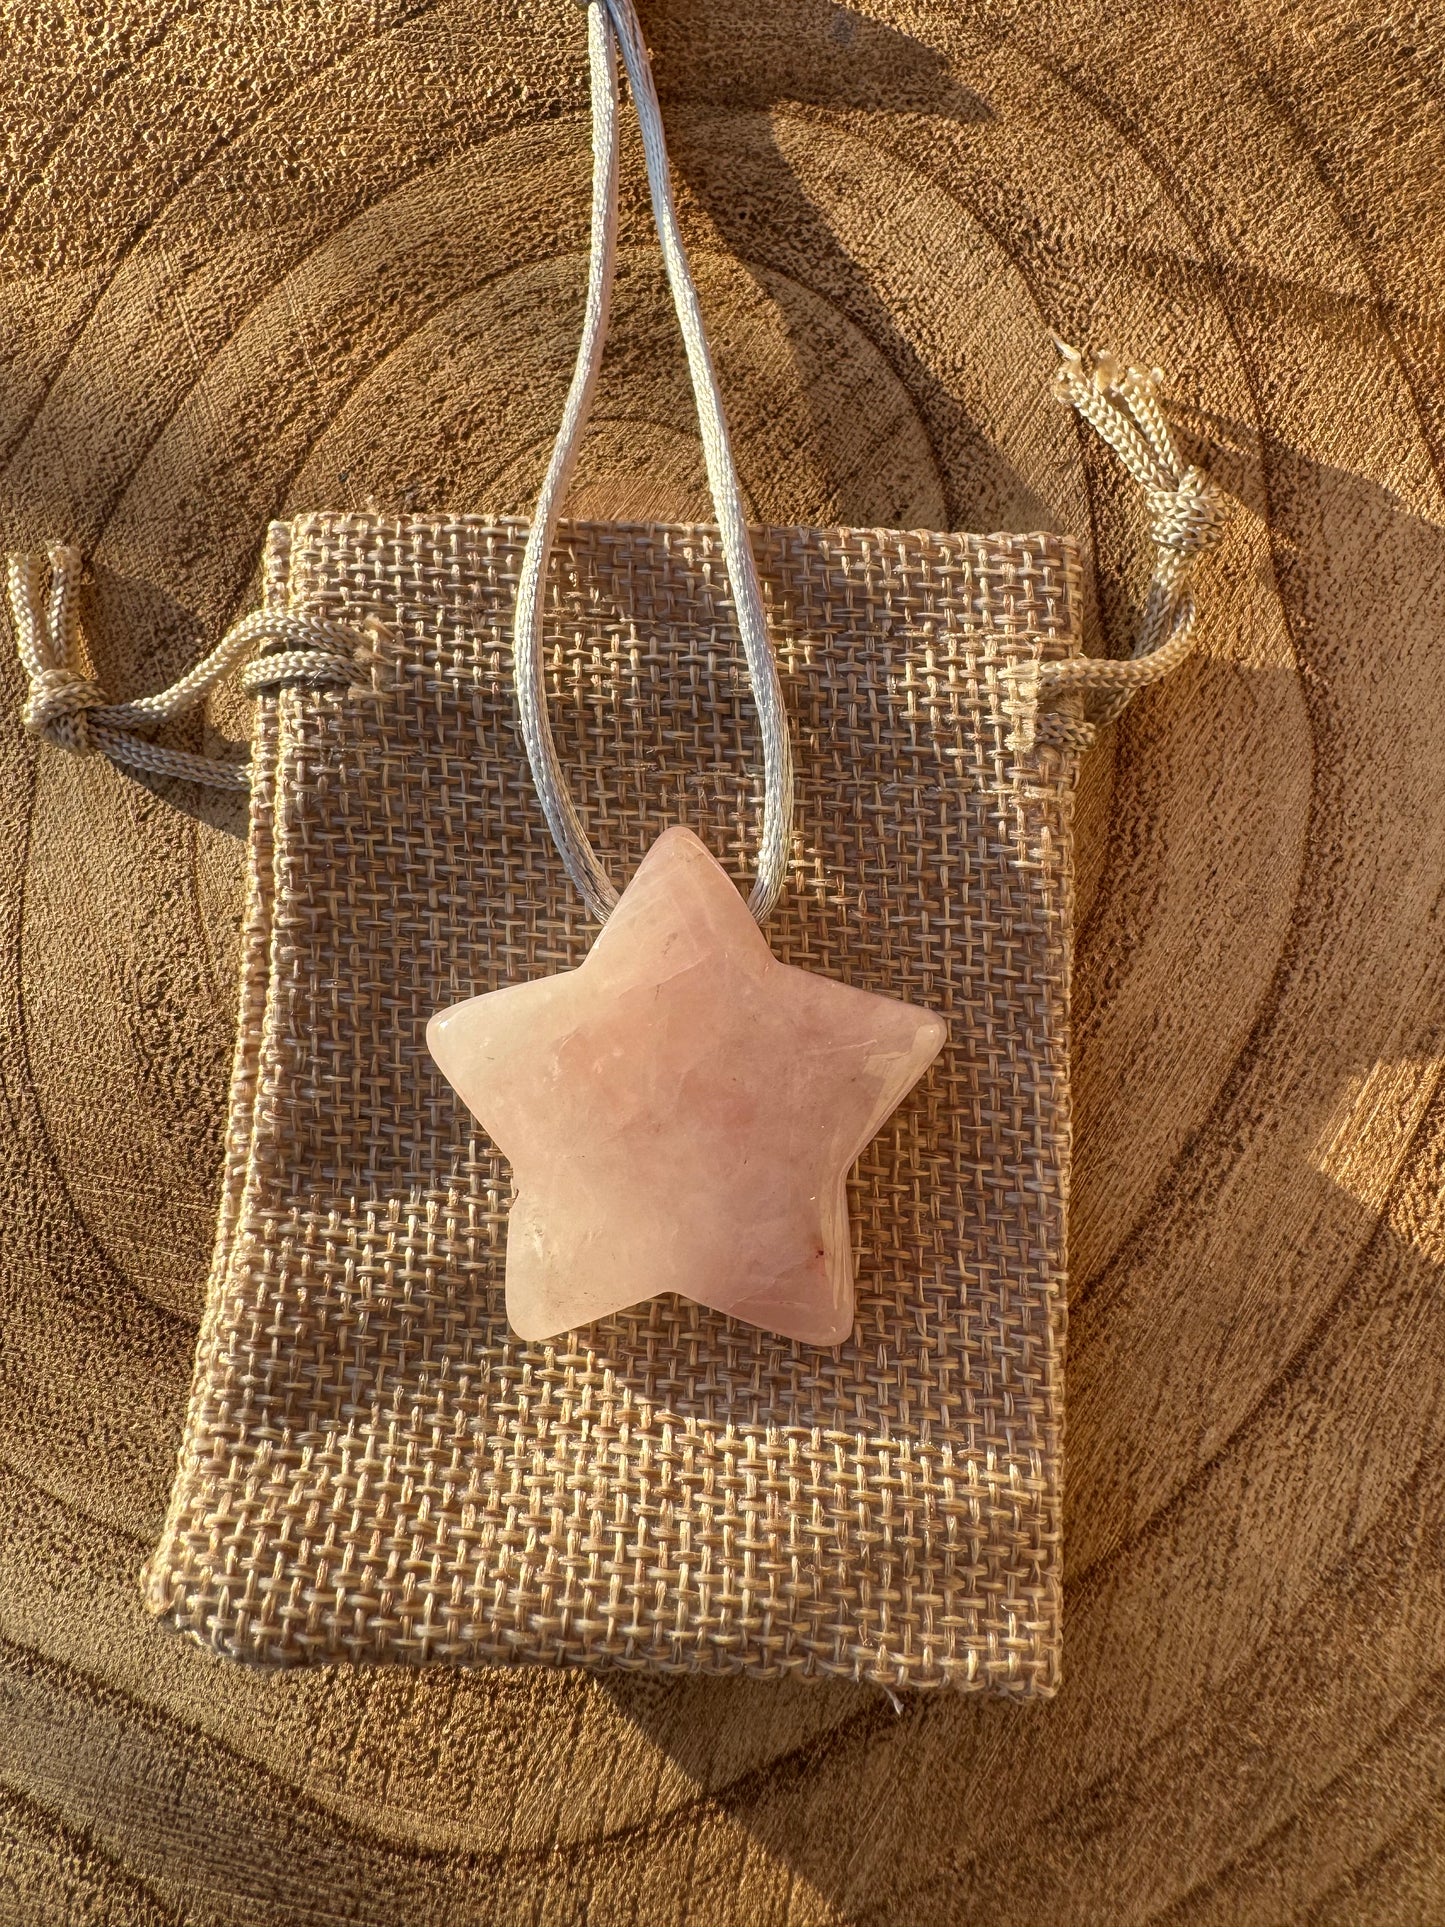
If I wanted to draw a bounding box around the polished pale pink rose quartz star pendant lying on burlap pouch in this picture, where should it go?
[426,829,944,1345]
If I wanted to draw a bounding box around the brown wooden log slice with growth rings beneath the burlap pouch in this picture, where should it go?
[0,0,1445,1927]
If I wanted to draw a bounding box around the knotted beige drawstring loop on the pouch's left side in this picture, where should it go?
[6,541,366,790]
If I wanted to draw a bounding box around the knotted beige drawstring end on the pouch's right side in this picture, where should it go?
[1035,341,1225,750]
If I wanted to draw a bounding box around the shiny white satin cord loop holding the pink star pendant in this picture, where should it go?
[512,0,794,923]
